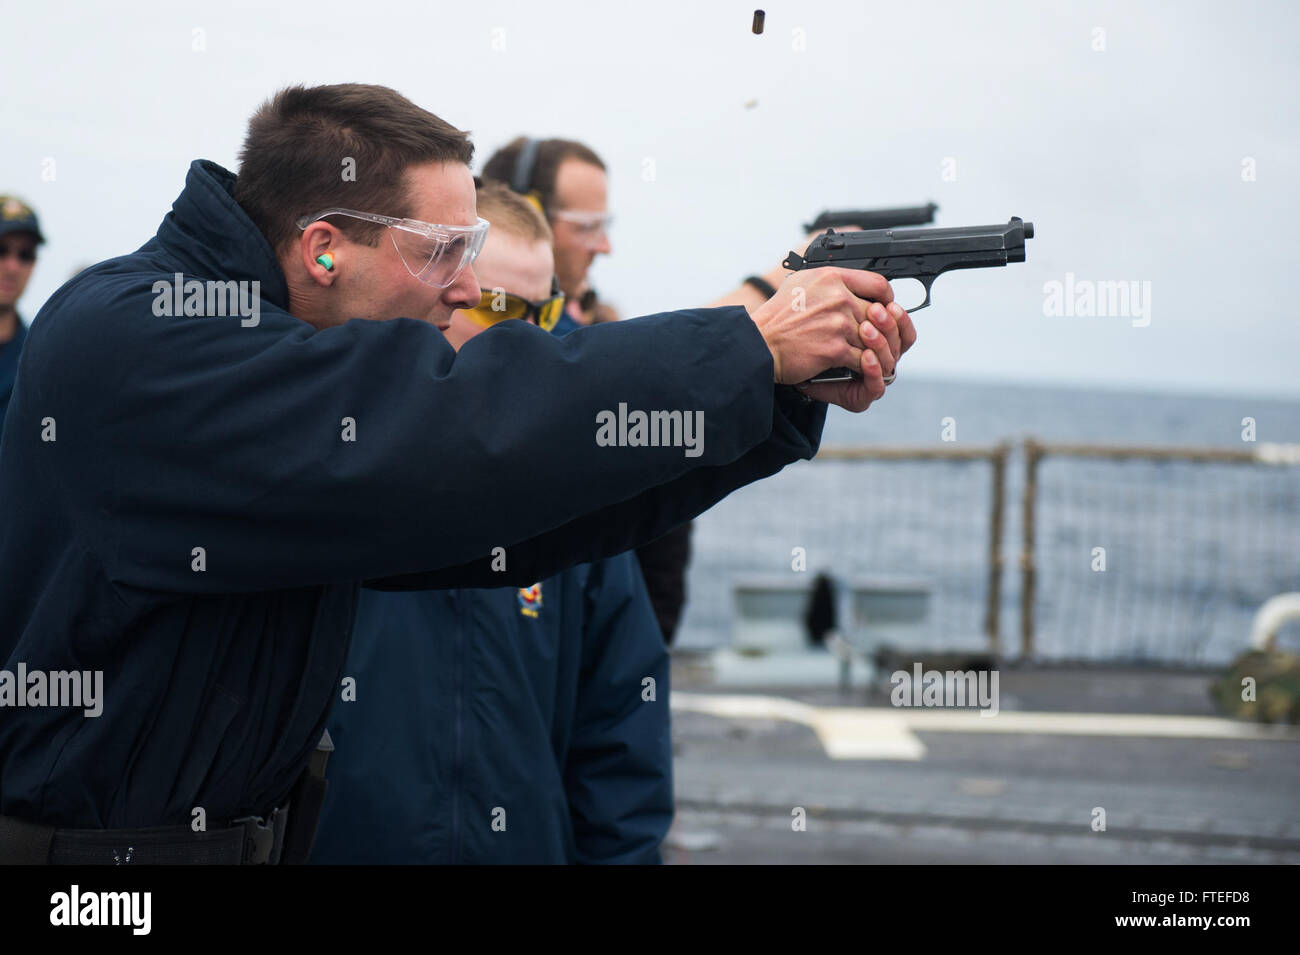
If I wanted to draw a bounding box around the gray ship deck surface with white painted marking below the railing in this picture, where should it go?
[664,657,1300,864]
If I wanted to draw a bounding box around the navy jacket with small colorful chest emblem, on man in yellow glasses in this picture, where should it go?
[312,554,672,864]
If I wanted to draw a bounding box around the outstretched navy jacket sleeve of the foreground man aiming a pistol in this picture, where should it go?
[20,266,820,595]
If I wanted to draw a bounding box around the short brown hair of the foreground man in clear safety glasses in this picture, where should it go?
[235,83,475,252]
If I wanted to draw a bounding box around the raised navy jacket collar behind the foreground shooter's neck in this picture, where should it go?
[157,160,289,309]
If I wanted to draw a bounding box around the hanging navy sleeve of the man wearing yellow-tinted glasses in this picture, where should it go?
[564,554,673,864]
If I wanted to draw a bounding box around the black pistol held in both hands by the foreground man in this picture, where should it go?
[781,216,1034,382]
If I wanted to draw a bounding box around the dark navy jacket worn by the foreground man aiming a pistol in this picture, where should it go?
[0,161,826,828]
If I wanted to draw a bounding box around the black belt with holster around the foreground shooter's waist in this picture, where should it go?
[0,732,334,865]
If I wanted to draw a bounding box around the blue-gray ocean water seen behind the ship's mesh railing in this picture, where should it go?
[677,378,1300,665]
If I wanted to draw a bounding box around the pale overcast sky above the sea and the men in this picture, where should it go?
[0,0,1300,396]
